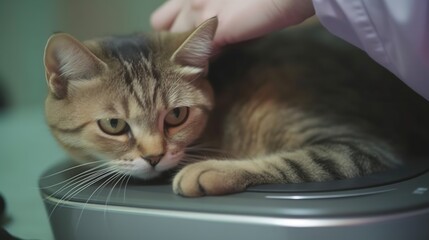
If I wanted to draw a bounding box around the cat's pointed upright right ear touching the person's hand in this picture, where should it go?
[171,17,218,74]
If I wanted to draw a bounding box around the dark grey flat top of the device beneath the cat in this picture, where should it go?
[39,162,429,218]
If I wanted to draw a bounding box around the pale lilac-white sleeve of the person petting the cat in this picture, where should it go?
[313,0,429,100]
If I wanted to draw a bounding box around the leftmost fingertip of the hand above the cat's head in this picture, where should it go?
[150,0,182,31]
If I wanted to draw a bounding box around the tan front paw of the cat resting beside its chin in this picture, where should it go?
[173,160,249,197]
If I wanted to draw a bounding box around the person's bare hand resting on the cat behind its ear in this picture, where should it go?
[151,0,314,49]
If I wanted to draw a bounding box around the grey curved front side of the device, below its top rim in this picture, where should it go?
[42,201,429,240]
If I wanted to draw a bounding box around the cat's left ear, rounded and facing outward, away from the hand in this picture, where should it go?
[44,33,107,99]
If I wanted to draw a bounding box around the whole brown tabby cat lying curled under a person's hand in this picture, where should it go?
[44,18,429,197]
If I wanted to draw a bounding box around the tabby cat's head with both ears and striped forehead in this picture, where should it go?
[44,18,217,179]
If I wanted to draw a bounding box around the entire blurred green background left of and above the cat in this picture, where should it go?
[0,0,164,240]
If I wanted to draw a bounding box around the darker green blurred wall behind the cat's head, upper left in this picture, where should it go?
[0,0,163,107]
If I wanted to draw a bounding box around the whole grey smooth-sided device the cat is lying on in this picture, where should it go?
[40,160,429,239]
